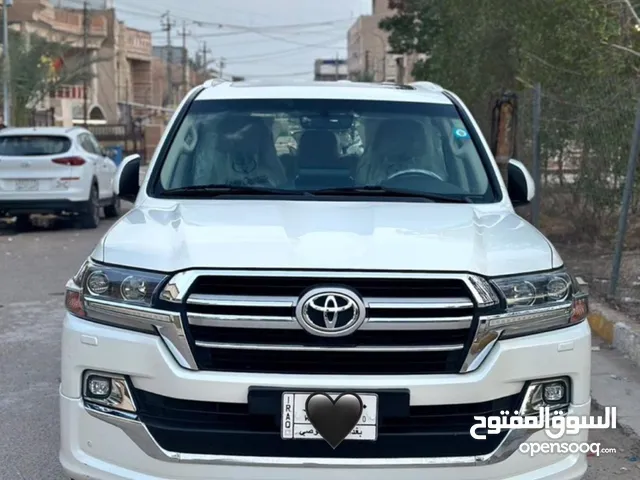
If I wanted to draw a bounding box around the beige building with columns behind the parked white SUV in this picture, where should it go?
[8,0,159,126]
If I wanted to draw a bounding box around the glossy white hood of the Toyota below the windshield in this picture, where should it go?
[94,200,559,276]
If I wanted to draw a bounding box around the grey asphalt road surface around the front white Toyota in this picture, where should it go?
[0,210,640,480]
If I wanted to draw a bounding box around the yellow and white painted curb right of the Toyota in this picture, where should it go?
[587,302,640,366]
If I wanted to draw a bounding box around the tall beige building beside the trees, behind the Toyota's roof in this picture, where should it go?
[347,0,421,83]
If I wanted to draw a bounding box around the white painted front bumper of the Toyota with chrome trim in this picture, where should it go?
[60,314,591,480]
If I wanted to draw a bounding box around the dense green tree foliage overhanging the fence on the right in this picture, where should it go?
[380,0,640,235]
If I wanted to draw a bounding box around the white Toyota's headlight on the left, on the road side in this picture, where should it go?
[65,260,175,333]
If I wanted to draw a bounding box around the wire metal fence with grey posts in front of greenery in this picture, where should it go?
[516,78,640,297]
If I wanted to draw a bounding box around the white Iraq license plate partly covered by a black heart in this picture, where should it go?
[281,392,378,441]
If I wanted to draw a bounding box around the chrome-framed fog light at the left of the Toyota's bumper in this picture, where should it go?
[82,372,136,413]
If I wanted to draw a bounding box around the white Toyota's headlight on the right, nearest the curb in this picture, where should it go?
[480,269,588,339]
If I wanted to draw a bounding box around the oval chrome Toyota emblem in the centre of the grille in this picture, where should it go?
[296,287,366,337]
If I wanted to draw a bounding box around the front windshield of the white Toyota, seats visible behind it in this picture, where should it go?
[150,99,497,203]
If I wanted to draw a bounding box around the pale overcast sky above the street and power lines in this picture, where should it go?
[79,0,371,79]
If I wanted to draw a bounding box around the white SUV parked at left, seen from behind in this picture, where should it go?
[0,127,120,228]
